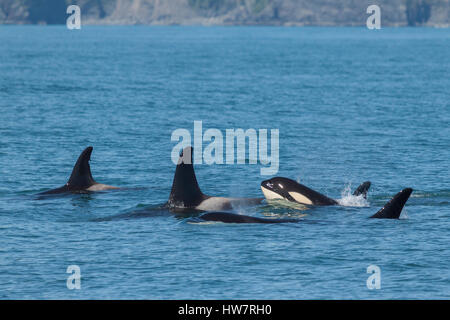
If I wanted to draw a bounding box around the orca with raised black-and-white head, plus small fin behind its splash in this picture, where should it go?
[261,177,370,206]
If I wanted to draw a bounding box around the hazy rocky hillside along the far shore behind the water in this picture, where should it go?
[0,0,450,26]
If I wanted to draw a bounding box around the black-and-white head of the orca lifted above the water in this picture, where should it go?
[261,177,304,203]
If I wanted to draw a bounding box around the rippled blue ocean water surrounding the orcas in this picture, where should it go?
[0,26,450,299]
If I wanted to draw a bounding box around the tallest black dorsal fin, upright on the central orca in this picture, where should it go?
[168,147,207,208]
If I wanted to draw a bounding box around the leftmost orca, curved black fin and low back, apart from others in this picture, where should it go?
[39,147,118,195]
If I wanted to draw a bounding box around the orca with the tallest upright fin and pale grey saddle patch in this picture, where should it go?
[167,146,264,211]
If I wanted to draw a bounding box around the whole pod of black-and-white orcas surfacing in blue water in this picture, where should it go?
[38,147,413,224]
